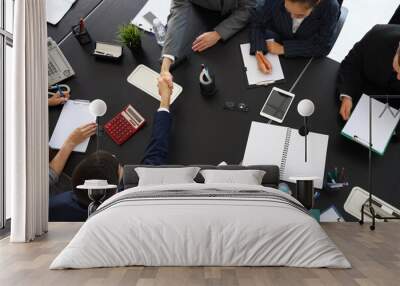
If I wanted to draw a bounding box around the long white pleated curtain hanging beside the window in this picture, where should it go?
[6,0,49,242]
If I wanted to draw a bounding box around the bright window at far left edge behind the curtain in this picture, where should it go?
[0,0,14,228]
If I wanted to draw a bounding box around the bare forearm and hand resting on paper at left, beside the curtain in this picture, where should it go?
[49,123,97,197]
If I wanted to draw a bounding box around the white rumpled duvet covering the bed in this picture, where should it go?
[50,184,351,269]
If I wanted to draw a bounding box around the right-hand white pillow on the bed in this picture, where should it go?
[200,170,265,185]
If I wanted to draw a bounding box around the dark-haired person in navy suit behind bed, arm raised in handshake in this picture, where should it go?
[49,78,172,221]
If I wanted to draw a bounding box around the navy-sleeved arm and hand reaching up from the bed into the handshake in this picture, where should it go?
[141,78,172,165]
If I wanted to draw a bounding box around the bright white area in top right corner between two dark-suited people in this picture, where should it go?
[328,0,400,62]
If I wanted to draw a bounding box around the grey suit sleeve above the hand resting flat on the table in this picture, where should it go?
[214,0,256,41]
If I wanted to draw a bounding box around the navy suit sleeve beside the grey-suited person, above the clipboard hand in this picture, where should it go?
[249,1,277,55]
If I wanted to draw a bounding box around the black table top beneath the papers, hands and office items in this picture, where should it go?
[49,0,400,220]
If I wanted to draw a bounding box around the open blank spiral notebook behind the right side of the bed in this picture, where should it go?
[242,121,329,189]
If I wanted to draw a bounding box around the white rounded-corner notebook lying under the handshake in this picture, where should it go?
[127,65,183,104]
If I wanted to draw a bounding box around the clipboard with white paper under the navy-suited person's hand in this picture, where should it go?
[240,43,285,85]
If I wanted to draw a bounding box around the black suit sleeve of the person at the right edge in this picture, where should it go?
[337,34,368,100]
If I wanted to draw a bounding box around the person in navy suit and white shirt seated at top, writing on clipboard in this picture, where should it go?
[250,0,340,72]
